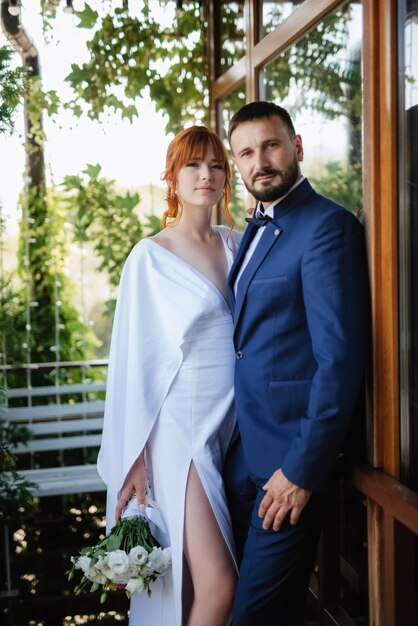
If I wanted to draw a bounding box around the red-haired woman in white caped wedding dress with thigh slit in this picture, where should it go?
[98,126,240,626]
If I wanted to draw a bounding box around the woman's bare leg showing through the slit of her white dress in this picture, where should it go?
[184,463,237,626]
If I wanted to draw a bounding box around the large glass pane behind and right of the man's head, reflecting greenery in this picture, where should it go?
[260,2,362,214]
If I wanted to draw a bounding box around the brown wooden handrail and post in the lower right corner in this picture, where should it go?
[310,465,418,626]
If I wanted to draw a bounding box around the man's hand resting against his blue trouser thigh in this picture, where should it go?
[258,469,311,530]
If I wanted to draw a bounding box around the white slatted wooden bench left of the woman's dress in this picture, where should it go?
[0,383,106,496]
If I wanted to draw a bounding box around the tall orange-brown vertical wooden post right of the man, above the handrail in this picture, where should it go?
[363,0,399,477]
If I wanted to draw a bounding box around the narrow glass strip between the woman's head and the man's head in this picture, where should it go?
[218,85,249,230]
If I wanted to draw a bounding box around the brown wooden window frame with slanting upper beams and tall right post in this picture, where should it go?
[209,0,418,626]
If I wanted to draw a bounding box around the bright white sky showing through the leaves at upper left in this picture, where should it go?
[0,0,172,232]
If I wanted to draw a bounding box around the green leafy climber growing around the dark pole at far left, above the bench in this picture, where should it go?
[0,42,94,384]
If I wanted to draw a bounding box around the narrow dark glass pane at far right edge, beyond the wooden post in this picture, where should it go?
[399,0,418,491]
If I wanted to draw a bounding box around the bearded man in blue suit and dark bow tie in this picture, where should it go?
[225,102,369,626]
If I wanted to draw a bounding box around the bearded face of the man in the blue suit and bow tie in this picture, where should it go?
[231,115,303,206]
